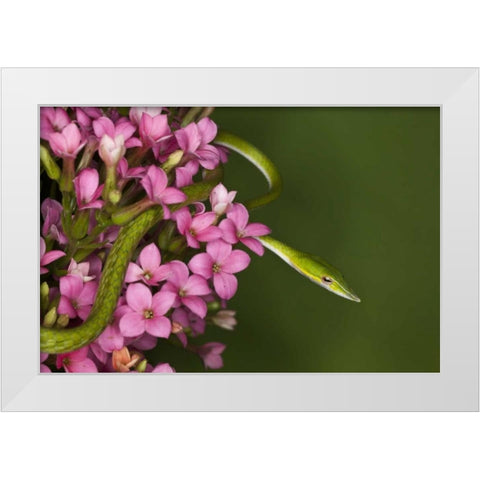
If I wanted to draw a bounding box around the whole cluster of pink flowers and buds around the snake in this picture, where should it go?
[40,107,270,372]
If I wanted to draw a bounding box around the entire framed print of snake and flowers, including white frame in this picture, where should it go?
[2,69,478,411]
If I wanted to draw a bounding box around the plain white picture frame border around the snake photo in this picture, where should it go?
[1,68,479,411]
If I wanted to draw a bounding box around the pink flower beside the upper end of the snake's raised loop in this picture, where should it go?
[175,118,220,170]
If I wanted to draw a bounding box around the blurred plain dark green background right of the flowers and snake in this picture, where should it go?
[153,107,440,372]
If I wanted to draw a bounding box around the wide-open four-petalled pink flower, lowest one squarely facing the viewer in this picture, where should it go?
[119,283,175,338]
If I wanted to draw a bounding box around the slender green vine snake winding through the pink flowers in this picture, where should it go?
[40,131,360,354]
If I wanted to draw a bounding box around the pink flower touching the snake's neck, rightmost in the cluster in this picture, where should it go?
[219,203,271,255]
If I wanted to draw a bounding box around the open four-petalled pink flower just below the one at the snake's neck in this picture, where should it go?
[188,240,250,300]
